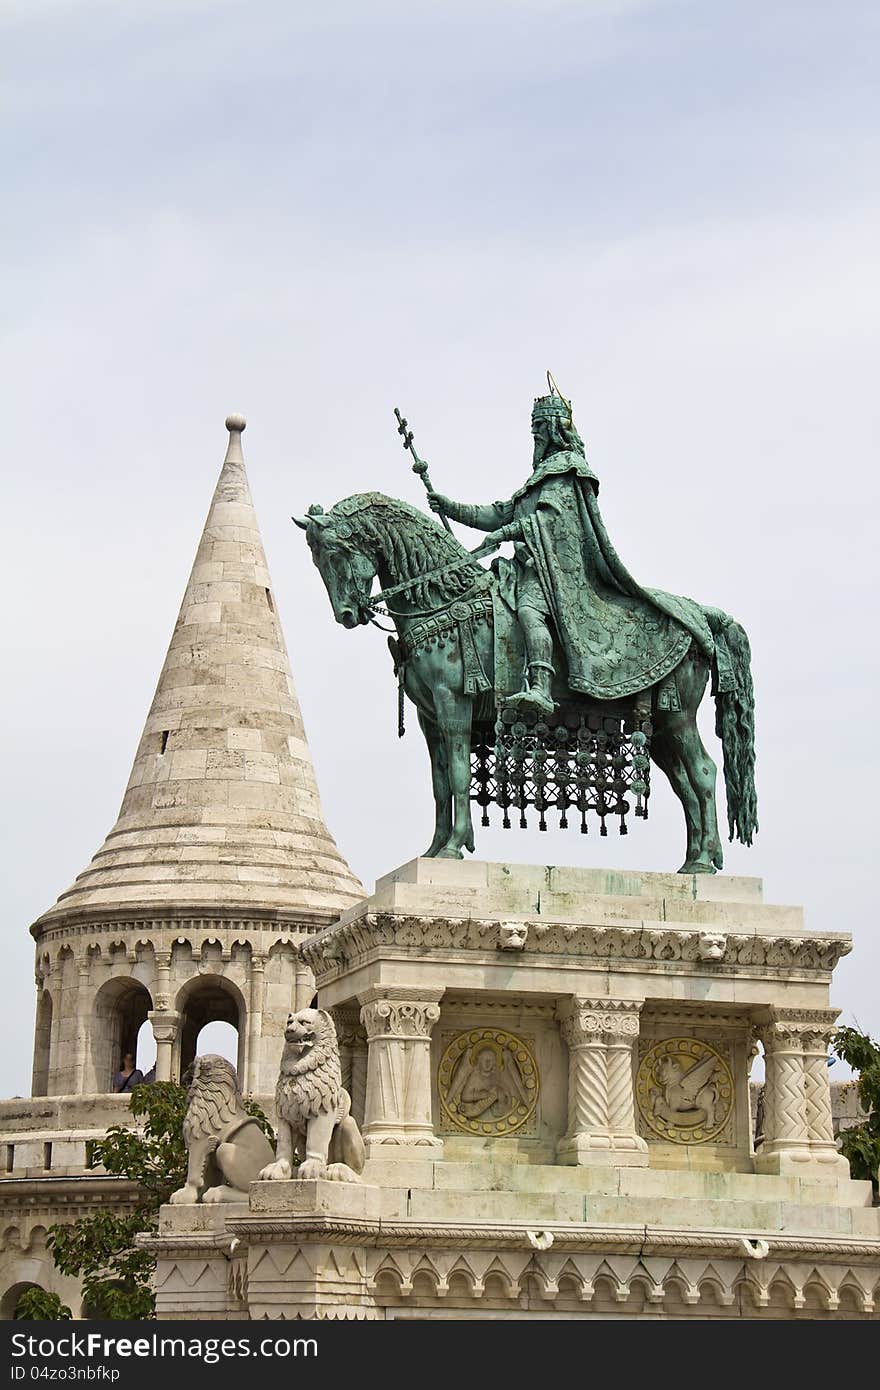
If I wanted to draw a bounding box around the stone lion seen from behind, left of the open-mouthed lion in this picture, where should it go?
[170,1054,272,1202]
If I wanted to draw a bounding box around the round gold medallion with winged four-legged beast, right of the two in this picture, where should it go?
[635,1038,734,1144]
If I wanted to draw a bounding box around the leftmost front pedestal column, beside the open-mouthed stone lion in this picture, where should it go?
[360,986,443,1158]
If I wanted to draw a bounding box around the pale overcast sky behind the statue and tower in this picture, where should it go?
[0,0,880,1095]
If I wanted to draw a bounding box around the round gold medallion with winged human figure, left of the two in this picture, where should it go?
[437,1029,538,1136]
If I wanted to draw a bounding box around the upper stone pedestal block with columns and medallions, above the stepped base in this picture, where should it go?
[302,859,849,1175]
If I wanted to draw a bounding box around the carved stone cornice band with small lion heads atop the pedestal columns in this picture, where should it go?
[300,912,852,983]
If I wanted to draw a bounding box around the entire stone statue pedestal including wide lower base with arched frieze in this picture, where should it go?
[145,860,880,1321]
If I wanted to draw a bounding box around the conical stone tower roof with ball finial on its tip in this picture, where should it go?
[35,416,364,931]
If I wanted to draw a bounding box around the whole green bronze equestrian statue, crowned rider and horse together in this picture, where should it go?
[293,386,758,873]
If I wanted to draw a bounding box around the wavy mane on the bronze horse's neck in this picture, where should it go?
[327,492,484,603]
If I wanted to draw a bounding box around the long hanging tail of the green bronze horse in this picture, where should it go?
[703,607,758,845]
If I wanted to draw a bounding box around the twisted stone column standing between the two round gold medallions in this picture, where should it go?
[556,995,648,1168]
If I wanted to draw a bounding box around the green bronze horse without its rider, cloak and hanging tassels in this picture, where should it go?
[293,492,758,873]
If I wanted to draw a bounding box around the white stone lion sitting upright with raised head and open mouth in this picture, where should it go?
[260,1009,364,1183]
